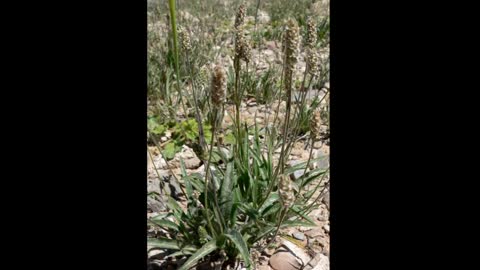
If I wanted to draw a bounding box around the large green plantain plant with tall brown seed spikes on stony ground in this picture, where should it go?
[148,0,328,270]
